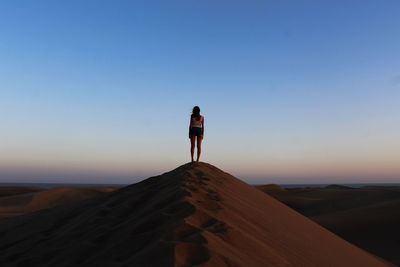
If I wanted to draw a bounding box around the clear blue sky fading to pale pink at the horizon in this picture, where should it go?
[0,0,400,183]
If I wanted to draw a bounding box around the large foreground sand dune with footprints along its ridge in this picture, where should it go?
[0,163,390,267]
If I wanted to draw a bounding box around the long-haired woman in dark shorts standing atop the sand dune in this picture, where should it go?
[189,106,204,162]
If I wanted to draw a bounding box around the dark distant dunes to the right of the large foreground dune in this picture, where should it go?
[256,185,400,265]
